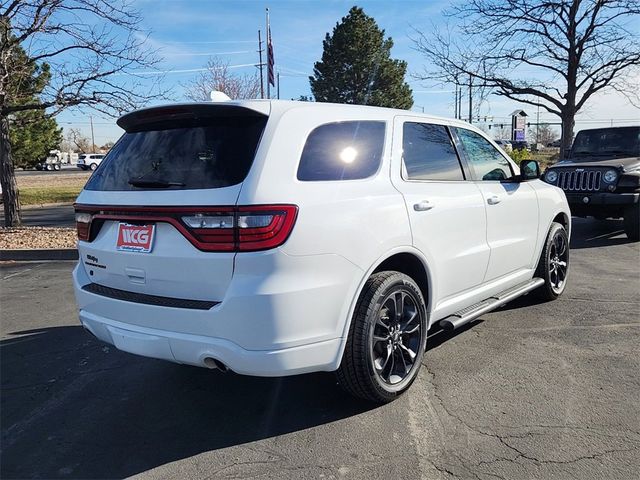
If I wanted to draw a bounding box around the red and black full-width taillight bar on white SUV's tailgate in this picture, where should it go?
[76,205,298,252]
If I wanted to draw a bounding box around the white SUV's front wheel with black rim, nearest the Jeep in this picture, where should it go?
[534,222,569,301]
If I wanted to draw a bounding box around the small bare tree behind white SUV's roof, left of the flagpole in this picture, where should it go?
[185,58,260,102]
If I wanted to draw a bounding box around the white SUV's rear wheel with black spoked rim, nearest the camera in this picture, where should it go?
[336,271,427,403]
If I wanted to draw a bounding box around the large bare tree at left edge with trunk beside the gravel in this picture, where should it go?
[0,0,162,226]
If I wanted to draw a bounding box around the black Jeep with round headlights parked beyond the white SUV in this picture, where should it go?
[543,126,640,241]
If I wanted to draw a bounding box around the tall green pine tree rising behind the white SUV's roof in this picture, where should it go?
[309,7,413,109]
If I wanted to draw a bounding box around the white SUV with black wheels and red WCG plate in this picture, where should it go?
[73,100,571,402]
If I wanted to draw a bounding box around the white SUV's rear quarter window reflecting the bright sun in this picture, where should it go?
[298,121,385,181]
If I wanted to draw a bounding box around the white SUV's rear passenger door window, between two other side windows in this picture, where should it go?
[402,122,464,180]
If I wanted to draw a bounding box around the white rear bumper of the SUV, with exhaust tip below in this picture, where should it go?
[73,251,363,376]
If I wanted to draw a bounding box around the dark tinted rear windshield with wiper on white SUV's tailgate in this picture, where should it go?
[85,116,267,191]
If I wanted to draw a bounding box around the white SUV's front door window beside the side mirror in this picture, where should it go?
[457,128,513,180]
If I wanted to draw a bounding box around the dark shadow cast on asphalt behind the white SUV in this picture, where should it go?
[0,326,375,478]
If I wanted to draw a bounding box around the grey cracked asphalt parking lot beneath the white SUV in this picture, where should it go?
[0,220,640,480]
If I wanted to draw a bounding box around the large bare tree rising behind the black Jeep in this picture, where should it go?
[414,0,640,158]
